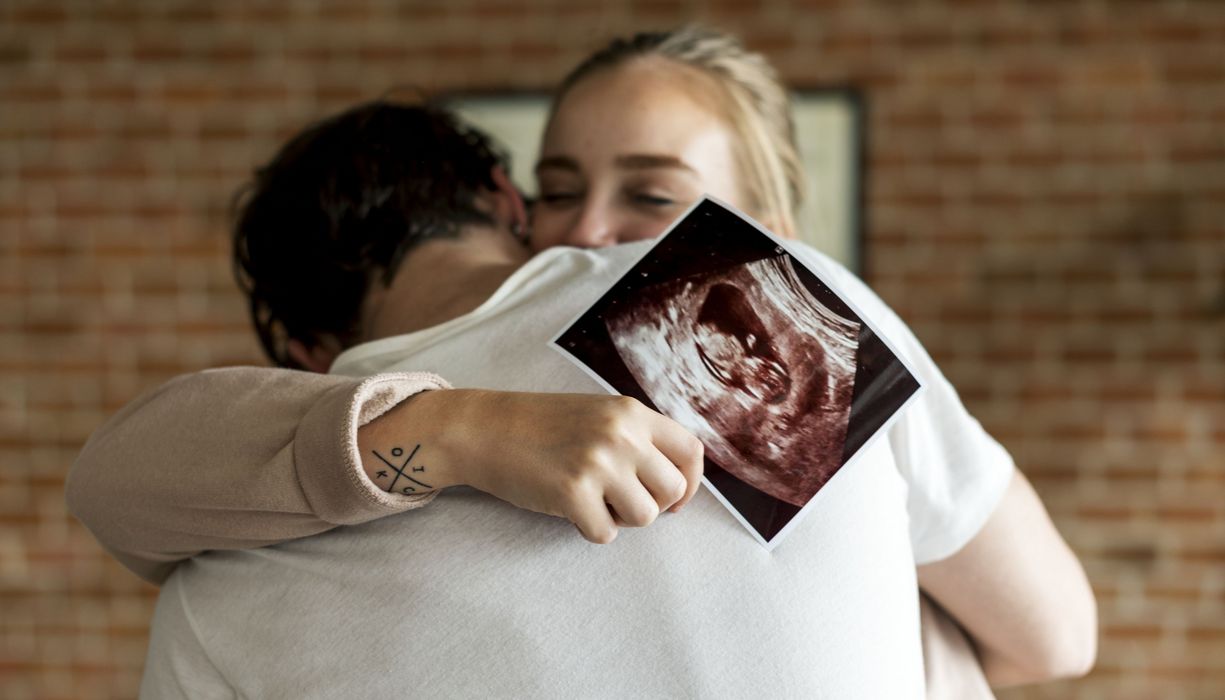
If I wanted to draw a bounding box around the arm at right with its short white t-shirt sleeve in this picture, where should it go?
[800,248,1096,685]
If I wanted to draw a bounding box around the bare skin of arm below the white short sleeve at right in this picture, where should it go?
[919,472,1098,687]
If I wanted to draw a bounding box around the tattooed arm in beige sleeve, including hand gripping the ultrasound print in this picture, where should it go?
[67,368,702,584]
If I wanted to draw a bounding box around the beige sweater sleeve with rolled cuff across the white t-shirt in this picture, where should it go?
[66,368,447,584]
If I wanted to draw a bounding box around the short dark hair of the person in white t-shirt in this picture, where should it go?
[234,101,507,367]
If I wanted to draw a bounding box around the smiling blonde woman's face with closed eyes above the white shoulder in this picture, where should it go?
[532,59,744,250]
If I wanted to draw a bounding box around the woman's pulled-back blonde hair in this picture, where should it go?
[552,26,804,235]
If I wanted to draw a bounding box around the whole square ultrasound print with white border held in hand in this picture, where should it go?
[554,200,919,548]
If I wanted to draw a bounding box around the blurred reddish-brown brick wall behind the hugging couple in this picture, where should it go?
[0,0,1225,700]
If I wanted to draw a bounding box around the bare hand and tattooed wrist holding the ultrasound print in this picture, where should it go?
[358,389,703,544]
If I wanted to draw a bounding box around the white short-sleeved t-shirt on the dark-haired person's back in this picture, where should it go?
[142,243,1013,699]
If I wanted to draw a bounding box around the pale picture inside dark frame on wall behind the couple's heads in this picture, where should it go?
[446,87,865,275]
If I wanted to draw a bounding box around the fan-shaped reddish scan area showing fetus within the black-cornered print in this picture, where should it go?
[604,255,860,508]
